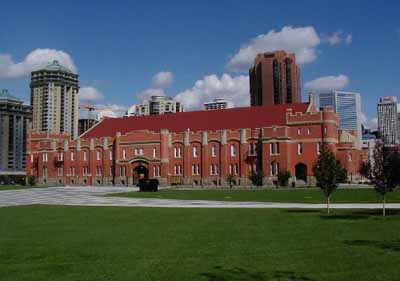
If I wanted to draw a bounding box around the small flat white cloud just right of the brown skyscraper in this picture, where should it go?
[305,74,350,91]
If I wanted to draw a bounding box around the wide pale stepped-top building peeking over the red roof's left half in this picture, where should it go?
[125,96,183,116]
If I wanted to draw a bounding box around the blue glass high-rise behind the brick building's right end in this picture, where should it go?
[319,91,362,145]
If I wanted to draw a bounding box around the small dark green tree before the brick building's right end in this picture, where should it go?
[313,146,347,214]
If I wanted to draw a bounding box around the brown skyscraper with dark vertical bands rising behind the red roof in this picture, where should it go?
[249,51,301,106]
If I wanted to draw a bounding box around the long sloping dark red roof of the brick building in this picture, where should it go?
[81,103,308,138]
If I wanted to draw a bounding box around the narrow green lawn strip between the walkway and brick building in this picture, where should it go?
[109,188,400,203]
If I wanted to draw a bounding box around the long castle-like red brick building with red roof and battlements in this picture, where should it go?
[27,96,360,186]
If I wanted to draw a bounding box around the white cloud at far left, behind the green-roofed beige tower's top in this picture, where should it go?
[0,49,77,78]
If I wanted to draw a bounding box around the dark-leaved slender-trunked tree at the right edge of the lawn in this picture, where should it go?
[360,141,400,216]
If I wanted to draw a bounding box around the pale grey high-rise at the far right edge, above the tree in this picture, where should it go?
[378,96,400,145]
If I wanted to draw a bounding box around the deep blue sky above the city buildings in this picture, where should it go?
[0,0,400,124]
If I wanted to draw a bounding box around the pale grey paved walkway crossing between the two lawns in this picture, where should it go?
[0,186,400,209]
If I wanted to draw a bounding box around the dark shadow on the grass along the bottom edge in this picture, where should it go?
[200,266,314,281]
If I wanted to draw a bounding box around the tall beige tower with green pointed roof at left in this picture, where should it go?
[31,61,79,138]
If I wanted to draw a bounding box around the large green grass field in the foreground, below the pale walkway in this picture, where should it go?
[0,203,400,281]
